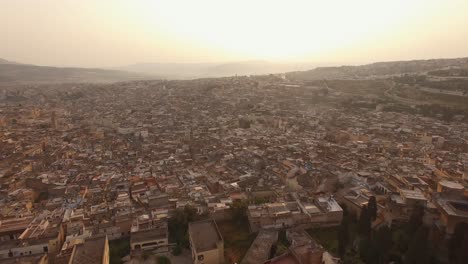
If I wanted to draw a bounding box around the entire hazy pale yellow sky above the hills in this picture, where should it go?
[0,0,468,67]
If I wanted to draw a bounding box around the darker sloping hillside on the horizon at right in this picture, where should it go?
[287,58,468,80]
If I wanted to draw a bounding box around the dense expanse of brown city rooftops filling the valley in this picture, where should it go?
[0,75,468,263]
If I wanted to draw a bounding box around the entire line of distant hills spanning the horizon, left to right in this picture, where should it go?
[0,58,468,85]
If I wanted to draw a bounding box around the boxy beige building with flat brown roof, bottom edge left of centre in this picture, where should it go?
[188,219,224,264]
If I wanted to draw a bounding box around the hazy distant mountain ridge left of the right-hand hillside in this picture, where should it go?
[0,58,310,85]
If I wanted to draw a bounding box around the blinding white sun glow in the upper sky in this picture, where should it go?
[143,0,422,60]
